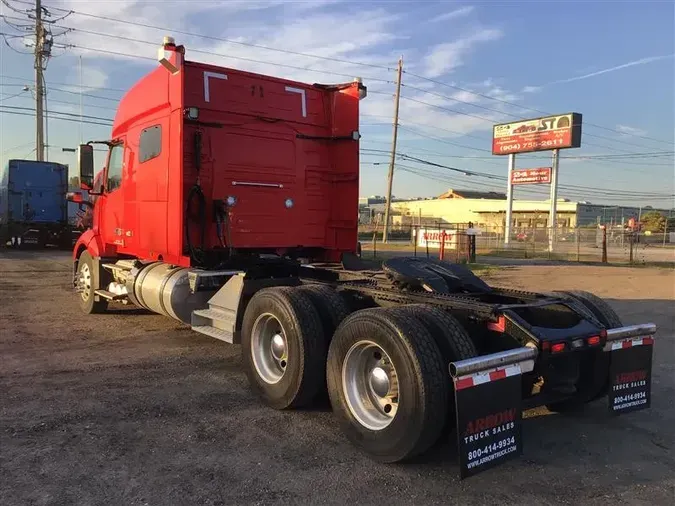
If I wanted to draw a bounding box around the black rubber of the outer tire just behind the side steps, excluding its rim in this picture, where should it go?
[241,287,326,409]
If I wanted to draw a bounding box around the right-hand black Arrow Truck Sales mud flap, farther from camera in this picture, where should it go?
[605,327,656,415]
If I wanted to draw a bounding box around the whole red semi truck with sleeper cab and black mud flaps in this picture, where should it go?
[71,37,656,477]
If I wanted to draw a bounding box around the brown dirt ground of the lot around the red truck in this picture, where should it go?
[0,252,675,506]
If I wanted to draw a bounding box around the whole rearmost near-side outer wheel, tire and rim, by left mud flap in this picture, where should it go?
[327,308,449,462]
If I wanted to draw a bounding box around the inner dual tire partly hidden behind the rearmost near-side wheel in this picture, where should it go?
[397,304,478,428]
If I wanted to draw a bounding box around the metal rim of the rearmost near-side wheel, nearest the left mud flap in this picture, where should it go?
[342,341,399,431]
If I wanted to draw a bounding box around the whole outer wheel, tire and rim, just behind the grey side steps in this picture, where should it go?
[241,287,326,409]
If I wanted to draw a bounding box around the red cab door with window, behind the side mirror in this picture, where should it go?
[97,138,126,250]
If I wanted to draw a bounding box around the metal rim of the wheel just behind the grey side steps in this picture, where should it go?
[251,313,288,385]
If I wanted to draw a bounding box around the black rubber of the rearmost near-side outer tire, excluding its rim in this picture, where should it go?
[327,308,449,463]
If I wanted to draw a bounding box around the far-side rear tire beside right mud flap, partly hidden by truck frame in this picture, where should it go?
[546,290,623,413]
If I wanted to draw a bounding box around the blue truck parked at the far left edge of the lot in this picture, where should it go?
[0,160,78,247]
